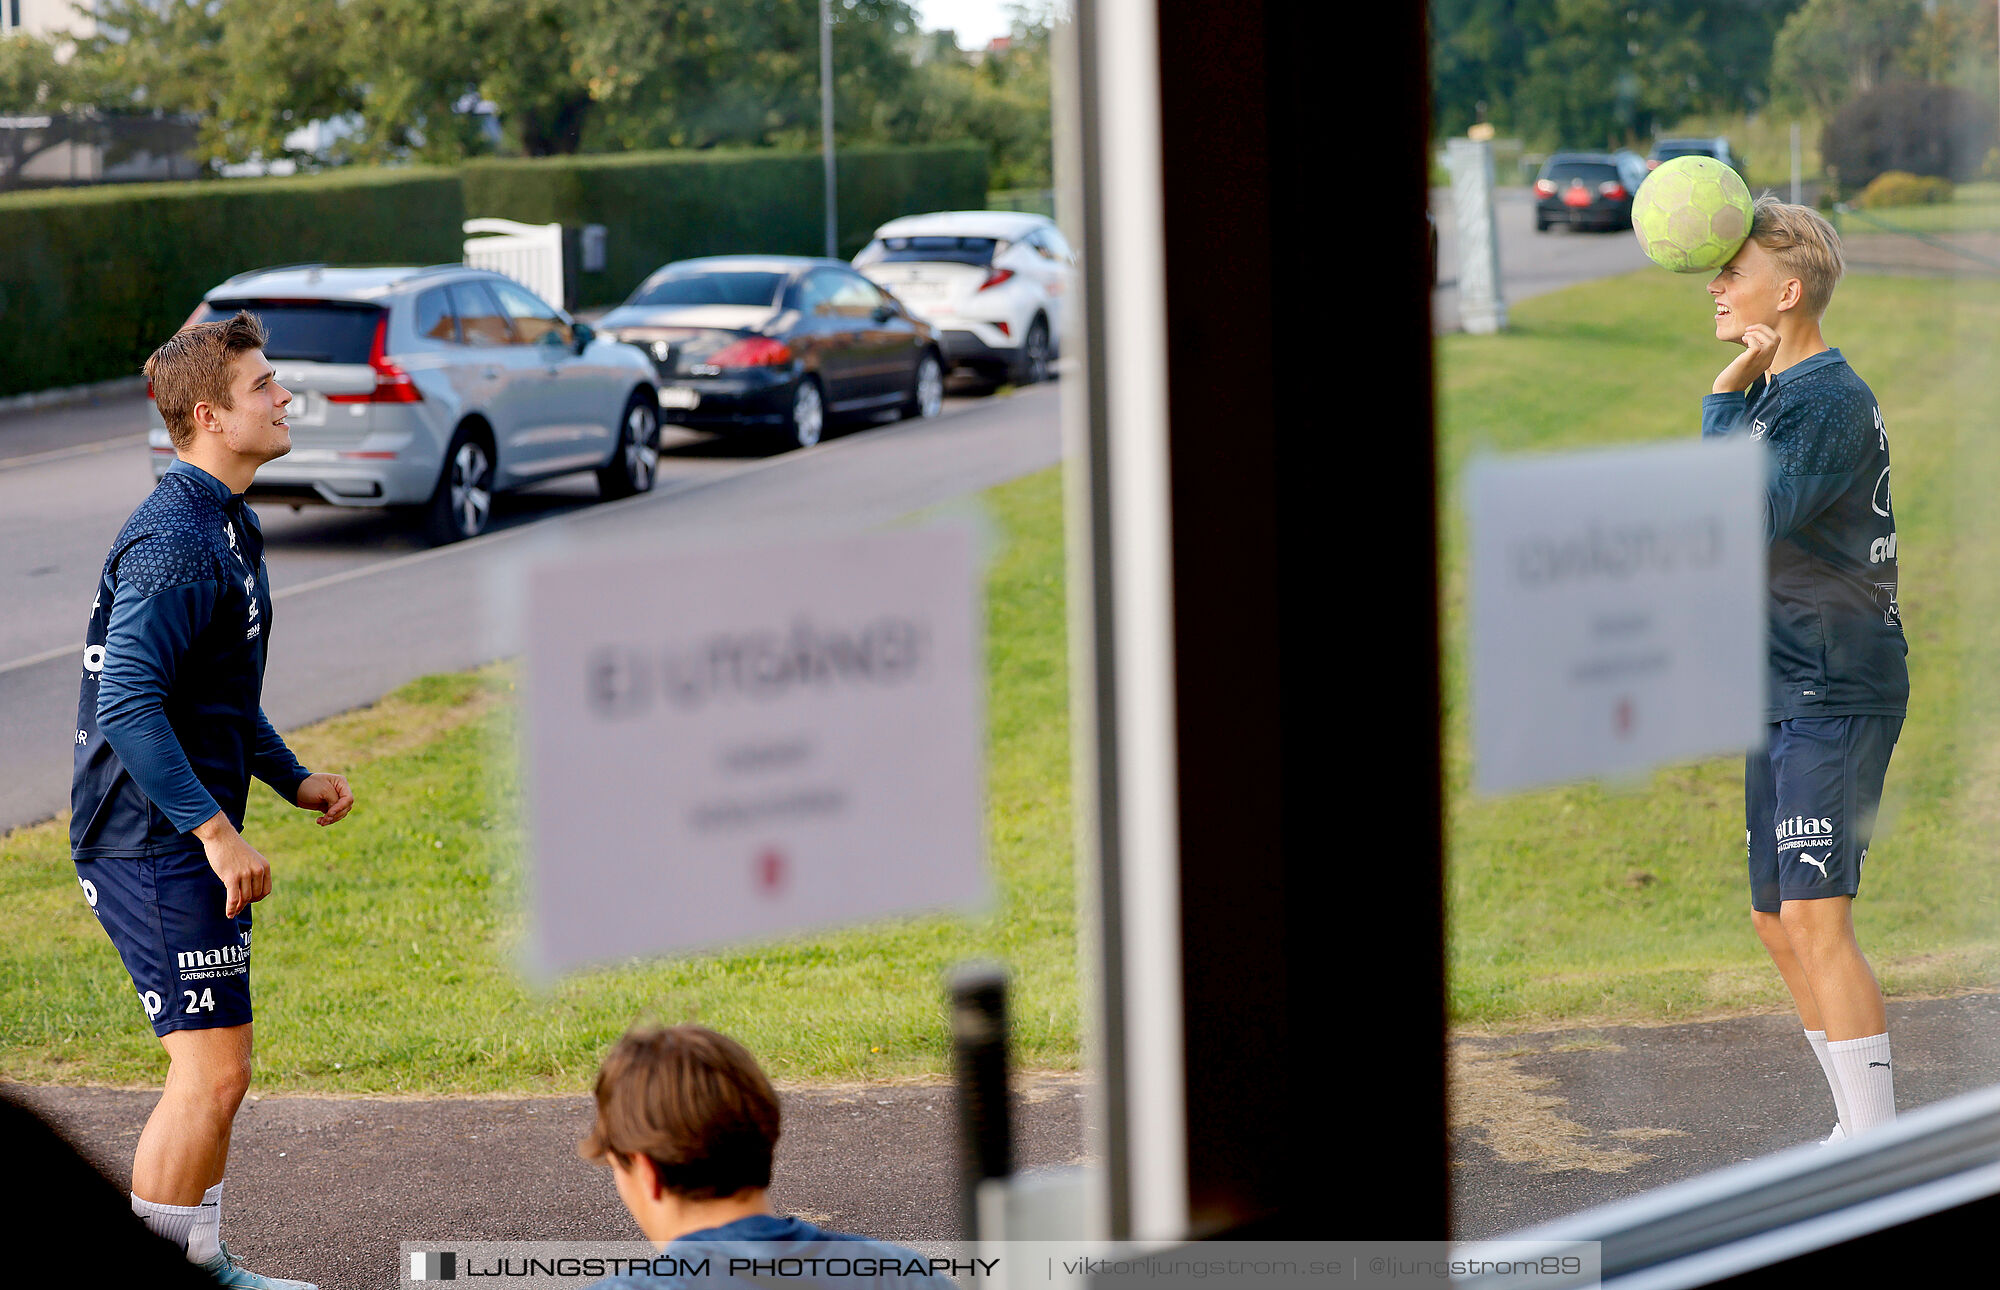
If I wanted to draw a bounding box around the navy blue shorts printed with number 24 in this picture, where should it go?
[76,852,250,1034]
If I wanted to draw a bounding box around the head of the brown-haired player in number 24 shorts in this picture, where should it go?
[146,312,292,478]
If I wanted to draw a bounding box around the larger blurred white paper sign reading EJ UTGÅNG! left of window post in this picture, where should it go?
[526,526,986,972]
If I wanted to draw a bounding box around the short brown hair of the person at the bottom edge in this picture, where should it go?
[578,1026,778,1200]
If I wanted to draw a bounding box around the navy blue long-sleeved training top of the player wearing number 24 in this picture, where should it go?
[70,462,306,860]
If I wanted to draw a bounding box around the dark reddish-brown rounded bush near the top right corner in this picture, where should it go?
[1820,82,1994,192]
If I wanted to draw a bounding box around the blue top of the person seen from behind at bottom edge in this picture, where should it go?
[590,1214,954,1290]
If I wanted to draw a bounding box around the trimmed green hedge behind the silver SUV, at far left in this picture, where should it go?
[0,170,466,396]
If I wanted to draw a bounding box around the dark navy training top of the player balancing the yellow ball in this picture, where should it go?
[1702,350,1910,722]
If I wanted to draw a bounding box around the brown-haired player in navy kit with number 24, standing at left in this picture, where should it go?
[70,314,354,1290]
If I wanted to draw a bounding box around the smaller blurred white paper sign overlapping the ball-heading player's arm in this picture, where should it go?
[1468,440,1768,792]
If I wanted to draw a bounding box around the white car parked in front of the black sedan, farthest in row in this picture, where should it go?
[854,210,1076,384]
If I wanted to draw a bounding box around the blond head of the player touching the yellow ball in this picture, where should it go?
[1708,192,1846,344]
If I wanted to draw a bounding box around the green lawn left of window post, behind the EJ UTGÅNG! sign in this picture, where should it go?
[0,470,1078,1094]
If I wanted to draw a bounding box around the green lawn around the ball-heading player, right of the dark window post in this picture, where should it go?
[1438,270,2000,1028]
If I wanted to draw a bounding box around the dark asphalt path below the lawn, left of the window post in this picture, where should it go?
[8,1074,1088,1290]
